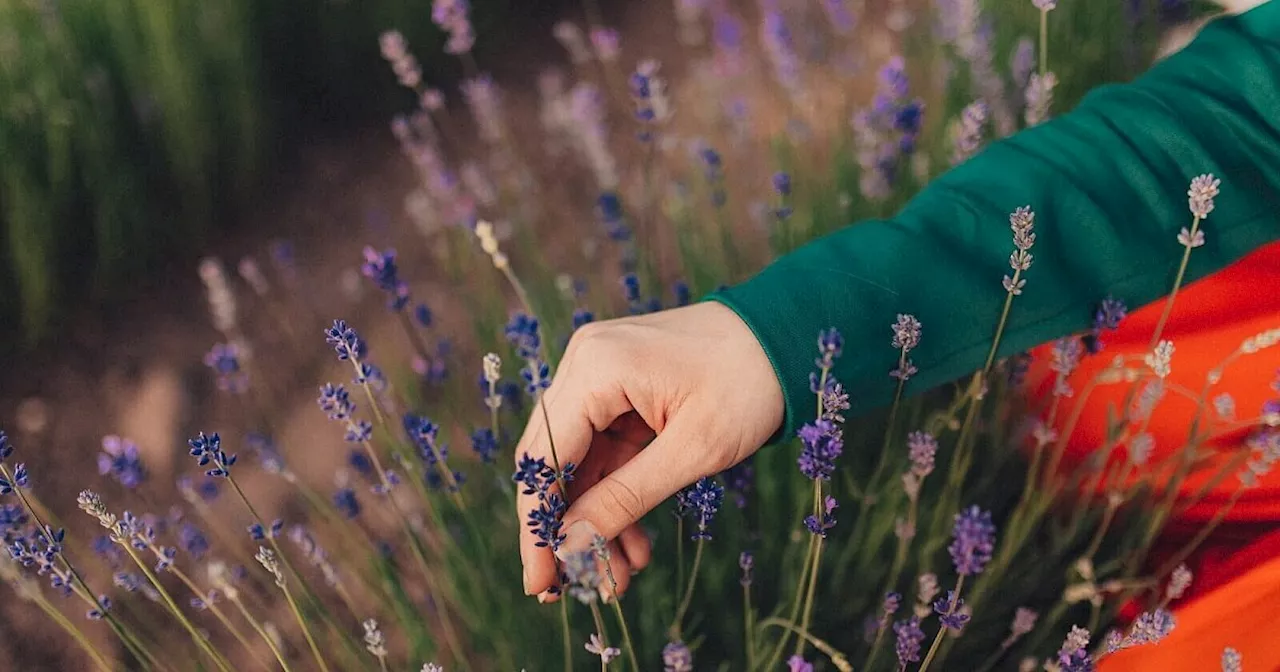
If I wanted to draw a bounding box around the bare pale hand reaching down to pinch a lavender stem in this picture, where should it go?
[516,302,783,602]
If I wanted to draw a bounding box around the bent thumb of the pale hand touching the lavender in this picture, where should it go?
[557,413,712,558]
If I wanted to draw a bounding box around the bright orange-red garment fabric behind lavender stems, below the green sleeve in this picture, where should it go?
[1033,243,1280,672]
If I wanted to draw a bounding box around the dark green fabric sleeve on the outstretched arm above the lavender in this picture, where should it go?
[710,0,1280,436]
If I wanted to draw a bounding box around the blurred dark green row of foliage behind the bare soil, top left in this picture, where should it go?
[0,0,599,343]
